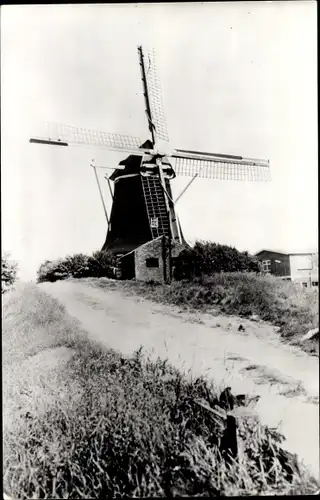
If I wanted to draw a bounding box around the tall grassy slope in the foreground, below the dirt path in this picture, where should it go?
[3,286,318,498]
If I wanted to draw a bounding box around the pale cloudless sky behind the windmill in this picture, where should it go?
[1,1,318,280]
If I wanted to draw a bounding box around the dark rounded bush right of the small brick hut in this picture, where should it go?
[175,241,260,280]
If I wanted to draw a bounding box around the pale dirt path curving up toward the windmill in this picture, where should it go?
[39,281,319,477]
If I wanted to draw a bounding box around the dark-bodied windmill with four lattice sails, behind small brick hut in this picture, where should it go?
[30,46,270,282]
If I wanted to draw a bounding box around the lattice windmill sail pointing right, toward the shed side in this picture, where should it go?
[172,150,271,181]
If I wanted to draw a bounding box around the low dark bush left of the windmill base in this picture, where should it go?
[37,251,117,283]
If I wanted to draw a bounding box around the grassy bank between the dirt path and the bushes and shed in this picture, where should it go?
[84,273,319,354]
